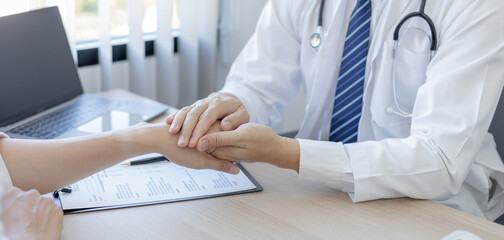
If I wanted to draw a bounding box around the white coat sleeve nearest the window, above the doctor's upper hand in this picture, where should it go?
[221,0,307,126]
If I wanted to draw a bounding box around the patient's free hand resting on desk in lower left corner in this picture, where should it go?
[1,188,63,239]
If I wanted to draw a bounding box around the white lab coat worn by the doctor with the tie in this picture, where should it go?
[222,0,504,220]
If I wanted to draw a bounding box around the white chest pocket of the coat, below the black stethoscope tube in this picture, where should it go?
[370,39,430,131]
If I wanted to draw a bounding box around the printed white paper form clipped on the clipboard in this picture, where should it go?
[59,162,261,210]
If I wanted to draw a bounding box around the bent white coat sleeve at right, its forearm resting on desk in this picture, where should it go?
[344,0,504,201]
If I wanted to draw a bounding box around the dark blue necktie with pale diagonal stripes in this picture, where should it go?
[329,0,371,143]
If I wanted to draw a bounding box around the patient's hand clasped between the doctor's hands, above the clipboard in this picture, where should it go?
[123,123,240,174]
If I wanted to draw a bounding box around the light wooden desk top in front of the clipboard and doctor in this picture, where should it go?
[62,91,504,239]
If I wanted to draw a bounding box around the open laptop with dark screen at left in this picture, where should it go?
[0,7,168,139]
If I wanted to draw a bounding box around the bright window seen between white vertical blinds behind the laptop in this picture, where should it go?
[0,0,180,67]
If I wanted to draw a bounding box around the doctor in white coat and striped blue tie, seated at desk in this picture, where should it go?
[167,0,504,220]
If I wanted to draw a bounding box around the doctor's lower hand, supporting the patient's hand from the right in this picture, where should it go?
[197,123,299,171]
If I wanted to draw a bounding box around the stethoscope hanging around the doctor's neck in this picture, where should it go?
[310,0,437,118]
